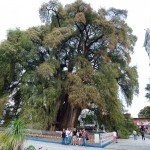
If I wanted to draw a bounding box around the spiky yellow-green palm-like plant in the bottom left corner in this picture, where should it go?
[0,119,25,150]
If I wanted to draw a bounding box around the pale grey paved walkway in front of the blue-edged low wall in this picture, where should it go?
[24,136,150,150]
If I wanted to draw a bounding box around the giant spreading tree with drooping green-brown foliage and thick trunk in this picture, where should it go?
[0,0,138,129]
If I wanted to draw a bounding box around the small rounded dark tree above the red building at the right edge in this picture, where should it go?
[138,106,150,118]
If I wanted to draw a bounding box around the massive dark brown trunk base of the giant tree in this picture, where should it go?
[56,96,81,130]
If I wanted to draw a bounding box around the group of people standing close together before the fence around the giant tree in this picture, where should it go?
[62,128,88,146]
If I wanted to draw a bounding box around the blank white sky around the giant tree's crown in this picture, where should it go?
[0,0,150,117]
